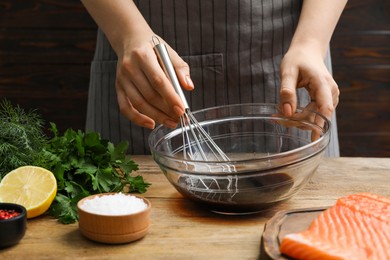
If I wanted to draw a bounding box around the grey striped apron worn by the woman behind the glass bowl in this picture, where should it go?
[86,0,339,156]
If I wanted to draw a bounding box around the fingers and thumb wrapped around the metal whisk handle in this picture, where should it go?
[118,41,194,128]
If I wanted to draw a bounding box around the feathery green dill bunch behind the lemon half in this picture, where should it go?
[0,99,47,180]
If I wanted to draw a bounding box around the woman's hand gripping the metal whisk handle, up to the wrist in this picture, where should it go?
[116,33,193,129]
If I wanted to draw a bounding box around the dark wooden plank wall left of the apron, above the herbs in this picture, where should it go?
[0,0,96,130]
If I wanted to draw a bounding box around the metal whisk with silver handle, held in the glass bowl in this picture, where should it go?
[152,36,230,161]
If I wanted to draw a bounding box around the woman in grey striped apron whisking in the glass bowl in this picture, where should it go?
[82,0,346,156]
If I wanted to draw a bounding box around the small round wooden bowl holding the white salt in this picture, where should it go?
[77,193,151,244]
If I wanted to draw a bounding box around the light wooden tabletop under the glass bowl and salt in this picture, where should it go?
[0,156,390,260]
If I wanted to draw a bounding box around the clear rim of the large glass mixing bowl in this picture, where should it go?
[148,103,332,164]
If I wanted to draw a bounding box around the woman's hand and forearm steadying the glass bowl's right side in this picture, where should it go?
[280,0,347,119]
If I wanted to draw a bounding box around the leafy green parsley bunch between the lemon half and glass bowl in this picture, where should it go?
[45,123,150,224]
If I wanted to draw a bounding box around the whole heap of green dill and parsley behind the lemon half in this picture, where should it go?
[0,99,150,224]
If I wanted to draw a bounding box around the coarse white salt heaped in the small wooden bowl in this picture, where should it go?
[81,193,148,216]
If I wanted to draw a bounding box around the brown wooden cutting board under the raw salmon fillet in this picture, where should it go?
[261,207,326,260]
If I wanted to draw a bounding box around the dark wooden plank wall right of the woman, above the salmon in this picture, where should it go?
[331,0,390,157]
